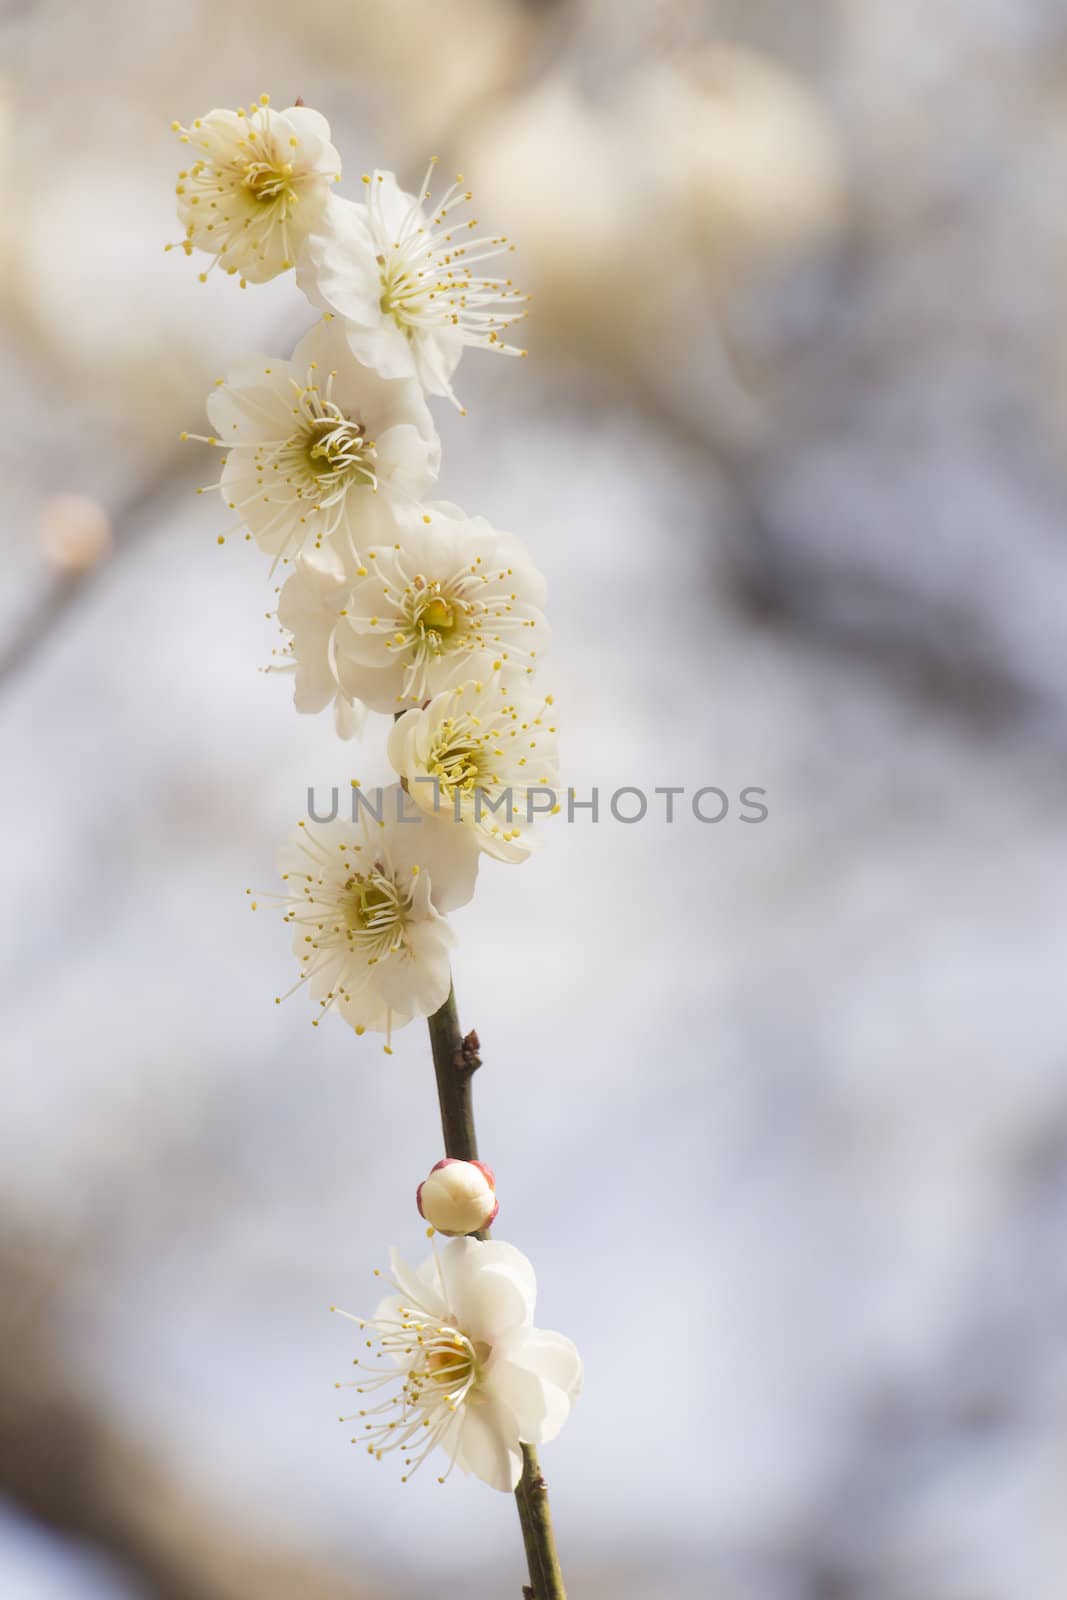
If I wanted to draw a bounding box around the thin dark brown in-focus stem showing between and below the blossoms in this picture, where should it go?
[427,987,566,1600]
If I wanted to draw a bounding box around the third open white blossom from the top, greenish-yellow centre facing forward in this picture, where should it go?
[199,322,440,573]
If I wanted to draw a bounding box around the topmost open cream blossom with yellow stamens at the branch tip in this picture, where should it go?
[168,94,341,286]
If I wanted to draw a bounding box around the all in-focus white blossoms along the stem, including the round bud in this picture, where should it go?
[170,96,582,1490]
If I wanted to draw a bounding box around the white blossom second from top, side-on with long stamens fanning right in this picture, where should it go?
[298,162,526,405]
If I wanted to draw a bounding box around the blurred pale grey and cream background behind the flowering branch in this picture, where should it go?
[0,0,1067,1600]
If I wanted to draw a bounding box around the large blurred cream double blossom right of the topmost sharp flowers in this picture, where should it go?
[464,45,845,371]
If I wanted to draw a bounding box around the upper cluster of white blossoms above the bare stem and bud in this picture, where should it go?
[170,96,558,1051]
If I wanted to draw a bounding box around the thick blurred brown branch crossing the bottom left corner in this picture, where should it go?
[0,1238,390,1600]
